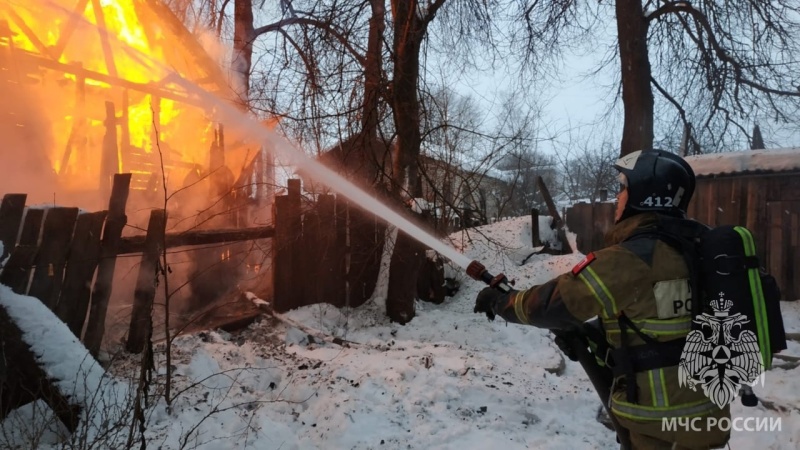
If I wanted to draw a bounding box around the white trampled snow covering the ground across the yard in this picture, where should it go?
[0,217,800,450]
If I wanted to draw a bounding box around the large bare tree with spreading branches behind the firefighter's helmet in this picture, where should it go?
[512,0,800,155]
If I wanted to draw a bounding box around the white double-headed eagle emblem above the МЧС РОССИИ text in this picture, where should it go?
[678,292,764,408]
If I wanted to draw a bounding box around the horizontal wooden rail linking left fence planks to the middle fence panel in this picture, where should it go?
[112,226,275,255]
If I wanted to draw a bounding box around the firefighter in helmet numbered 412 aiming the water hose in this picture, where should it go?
[475,150,730,450]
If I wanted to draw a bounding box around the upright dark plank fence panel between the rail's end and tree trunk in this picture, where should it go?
[273,179,386,311]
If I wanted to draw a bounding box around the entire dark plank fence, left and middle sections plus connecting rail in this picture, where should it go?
[0,174,444,356]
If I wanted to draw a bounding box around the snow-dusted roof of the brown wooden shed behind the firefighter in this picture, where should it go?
[686,148,800,177]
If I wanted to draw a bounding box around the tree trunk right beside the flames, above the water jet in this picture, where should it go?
[231,0,255,107]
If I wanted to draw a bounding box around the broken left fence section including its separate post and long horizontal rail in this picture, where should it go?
[0,174,275,357]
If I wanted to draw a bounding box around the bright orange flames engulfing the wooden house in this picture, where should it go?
[0,0,238,207]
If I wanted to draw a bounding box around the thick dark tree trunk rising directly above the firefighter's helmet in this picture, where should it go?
[616,0,653,156]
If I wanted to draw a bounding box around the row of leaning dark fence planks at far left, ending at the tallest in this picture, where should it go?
[0,174,130,356]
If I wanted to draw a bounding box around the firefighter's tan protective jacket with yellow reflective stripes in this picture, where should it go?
[494,213,730,448]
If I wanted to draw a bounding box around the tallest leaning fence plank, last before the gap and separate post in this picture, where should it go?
[83,173,131,358]
